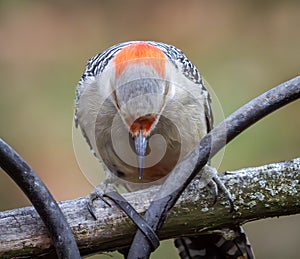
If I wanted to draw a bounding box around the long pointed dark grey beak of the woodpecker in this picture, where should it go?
[134,130,148,180]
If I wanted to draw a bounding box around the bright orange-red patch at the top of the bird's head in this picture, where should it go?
[113,42,166,77]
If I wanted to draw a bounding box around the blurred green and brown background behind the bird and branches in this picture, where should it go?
[0,0,300,258]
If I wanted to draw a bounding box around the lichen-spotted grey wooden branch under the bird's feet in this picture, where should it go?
[0,158,300,258]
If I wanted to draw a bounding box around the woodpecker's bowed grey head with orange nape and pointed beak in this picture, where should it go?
[113,42,170,180]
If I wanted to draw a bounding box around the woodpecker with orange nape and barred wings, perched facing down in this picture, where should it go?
[75,41,253,258]
